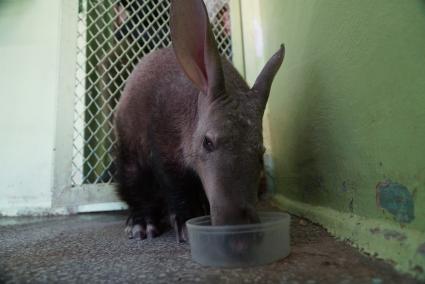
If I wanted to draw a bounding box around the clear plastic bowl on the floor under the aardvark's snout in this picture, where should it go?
[186,212,290,267]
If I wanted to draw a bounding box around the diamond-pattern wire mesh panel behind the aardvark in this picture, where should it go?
[71,0,232,186]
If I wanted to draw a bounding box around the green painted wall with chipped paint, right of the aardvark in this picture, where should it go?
[241,0,425,278]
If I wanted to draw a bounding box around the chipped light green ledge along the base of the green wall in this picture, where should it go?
[274,194,425,280]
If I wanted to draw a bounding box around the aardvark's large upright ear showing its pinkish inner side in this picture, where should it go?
[170,0,224,94]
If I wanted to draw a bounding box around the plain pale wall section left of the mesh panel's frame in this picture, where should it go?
[0,0,61,215]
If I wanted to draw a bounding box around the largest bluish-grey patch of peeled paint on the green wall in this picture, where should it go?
[376,180,415,223]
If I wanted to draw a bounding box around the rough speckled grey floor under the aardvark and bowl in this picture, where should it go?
[0,207,416,284]
